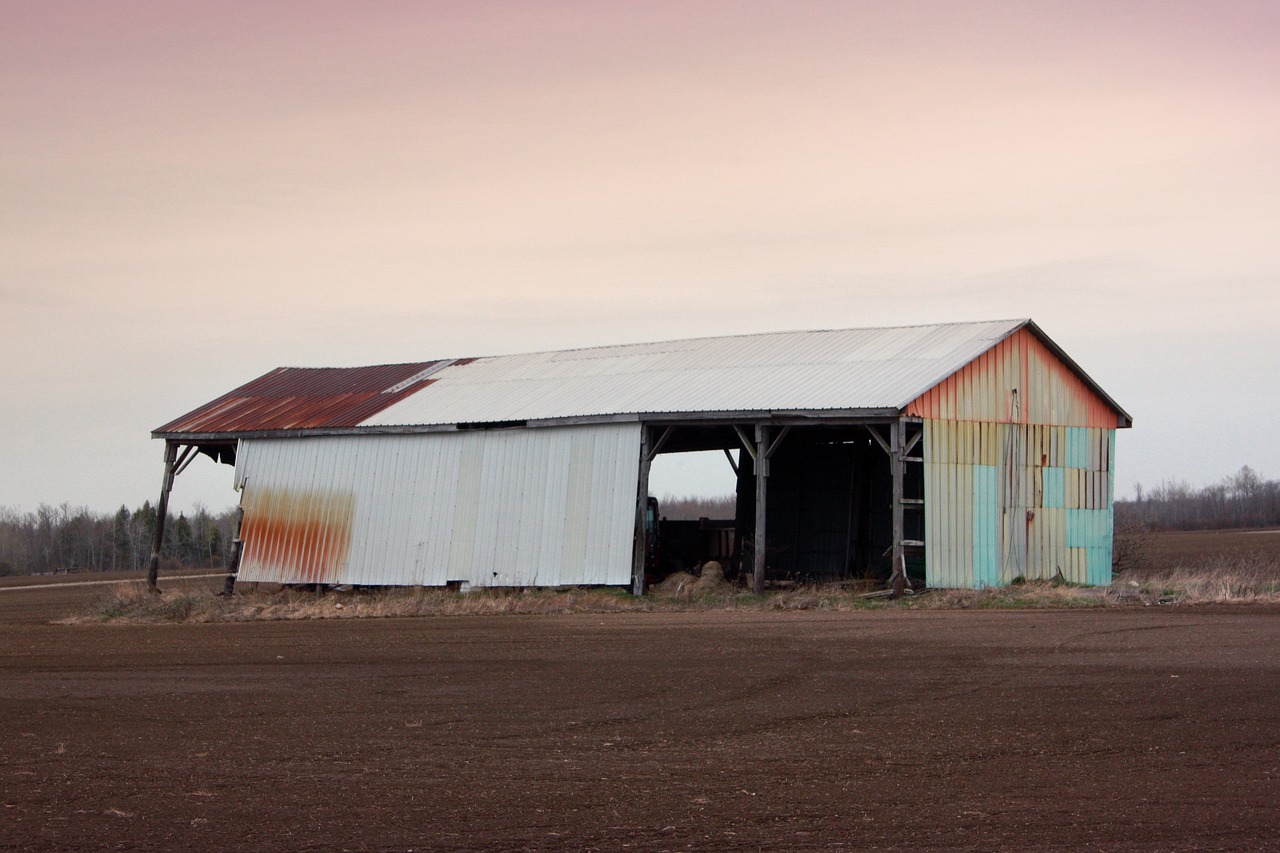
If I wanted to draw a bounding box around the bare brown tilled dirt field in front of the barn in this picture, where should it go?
[0,580,1280,850]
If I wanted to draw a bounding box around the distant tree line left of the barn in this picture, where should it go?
[0,501,237,576]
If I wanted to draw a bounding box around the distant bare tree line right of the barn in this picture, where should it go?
[1115,465,1280,530]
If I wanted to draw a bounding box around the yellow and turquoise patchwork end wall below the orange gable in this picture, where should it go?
[924,419,1115,587]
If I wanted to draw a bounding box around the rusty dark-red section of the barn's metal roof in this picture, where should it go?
[155,361,449,435]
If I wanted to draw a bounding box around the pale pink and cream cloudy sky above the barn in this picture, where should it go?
[0,0,1280,511]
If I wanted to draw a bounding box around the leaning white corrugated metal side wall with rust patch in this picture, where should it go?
[236,424,640,587]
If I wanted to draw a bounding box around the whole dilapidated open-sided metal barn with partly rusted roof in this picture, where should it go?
[151,320,1132,593]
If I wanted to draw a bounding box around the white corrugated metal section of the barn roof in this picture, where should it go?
[362,320,1027,427]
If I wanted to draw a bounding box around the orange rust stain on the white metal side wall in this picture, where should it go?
[241,488,356,584]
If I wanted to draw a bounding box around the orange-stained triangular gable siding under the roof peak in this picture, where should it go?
[906,328,1117,429]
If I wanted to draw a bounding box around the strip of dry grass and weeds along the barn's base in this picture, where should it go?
[64,557,1280,622]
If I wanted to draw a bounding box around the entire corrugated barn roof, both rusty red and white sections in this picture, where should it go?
[155,320,1124,437]
